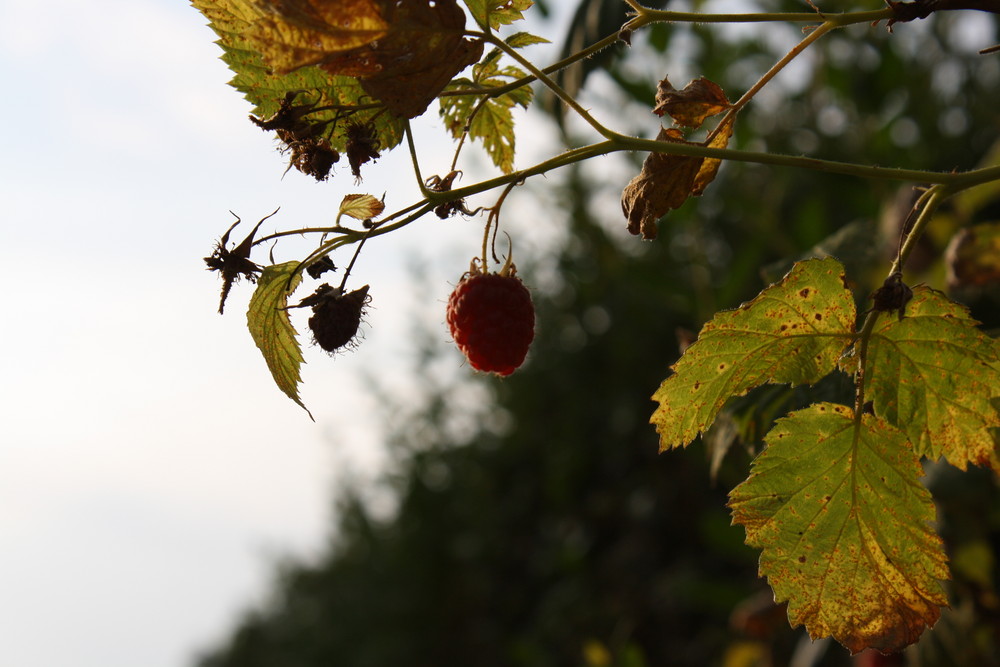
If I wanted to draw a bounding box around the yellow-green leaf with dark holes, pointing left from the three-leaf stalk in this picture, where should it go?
[650,258,856,451]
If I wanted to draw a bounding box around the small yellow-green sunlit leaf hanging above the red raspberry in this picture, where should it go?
[441,57,532,174]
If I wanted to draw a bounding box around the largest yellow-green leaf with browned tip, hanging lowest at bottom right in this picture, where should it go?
[729,403,948,652]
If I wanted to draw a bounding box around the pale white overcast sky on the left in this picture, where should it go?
[0,0,564,667]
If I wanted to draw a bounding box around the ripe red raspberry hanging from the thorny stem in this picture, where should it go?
[448,273,535,375]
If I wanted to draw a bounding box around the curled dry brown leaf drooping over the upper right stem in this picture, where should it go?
[622,119,733,239]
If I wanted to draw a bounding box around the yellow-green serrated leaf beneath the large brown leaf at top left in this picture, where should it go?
[192,0,405,151]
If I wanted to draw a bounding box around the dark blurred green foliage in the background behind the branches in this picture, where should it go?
[199,5,1000,667]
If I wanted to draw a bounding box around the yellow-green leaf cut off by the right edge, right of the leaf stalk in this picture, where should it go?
[865,285,1000,472]
